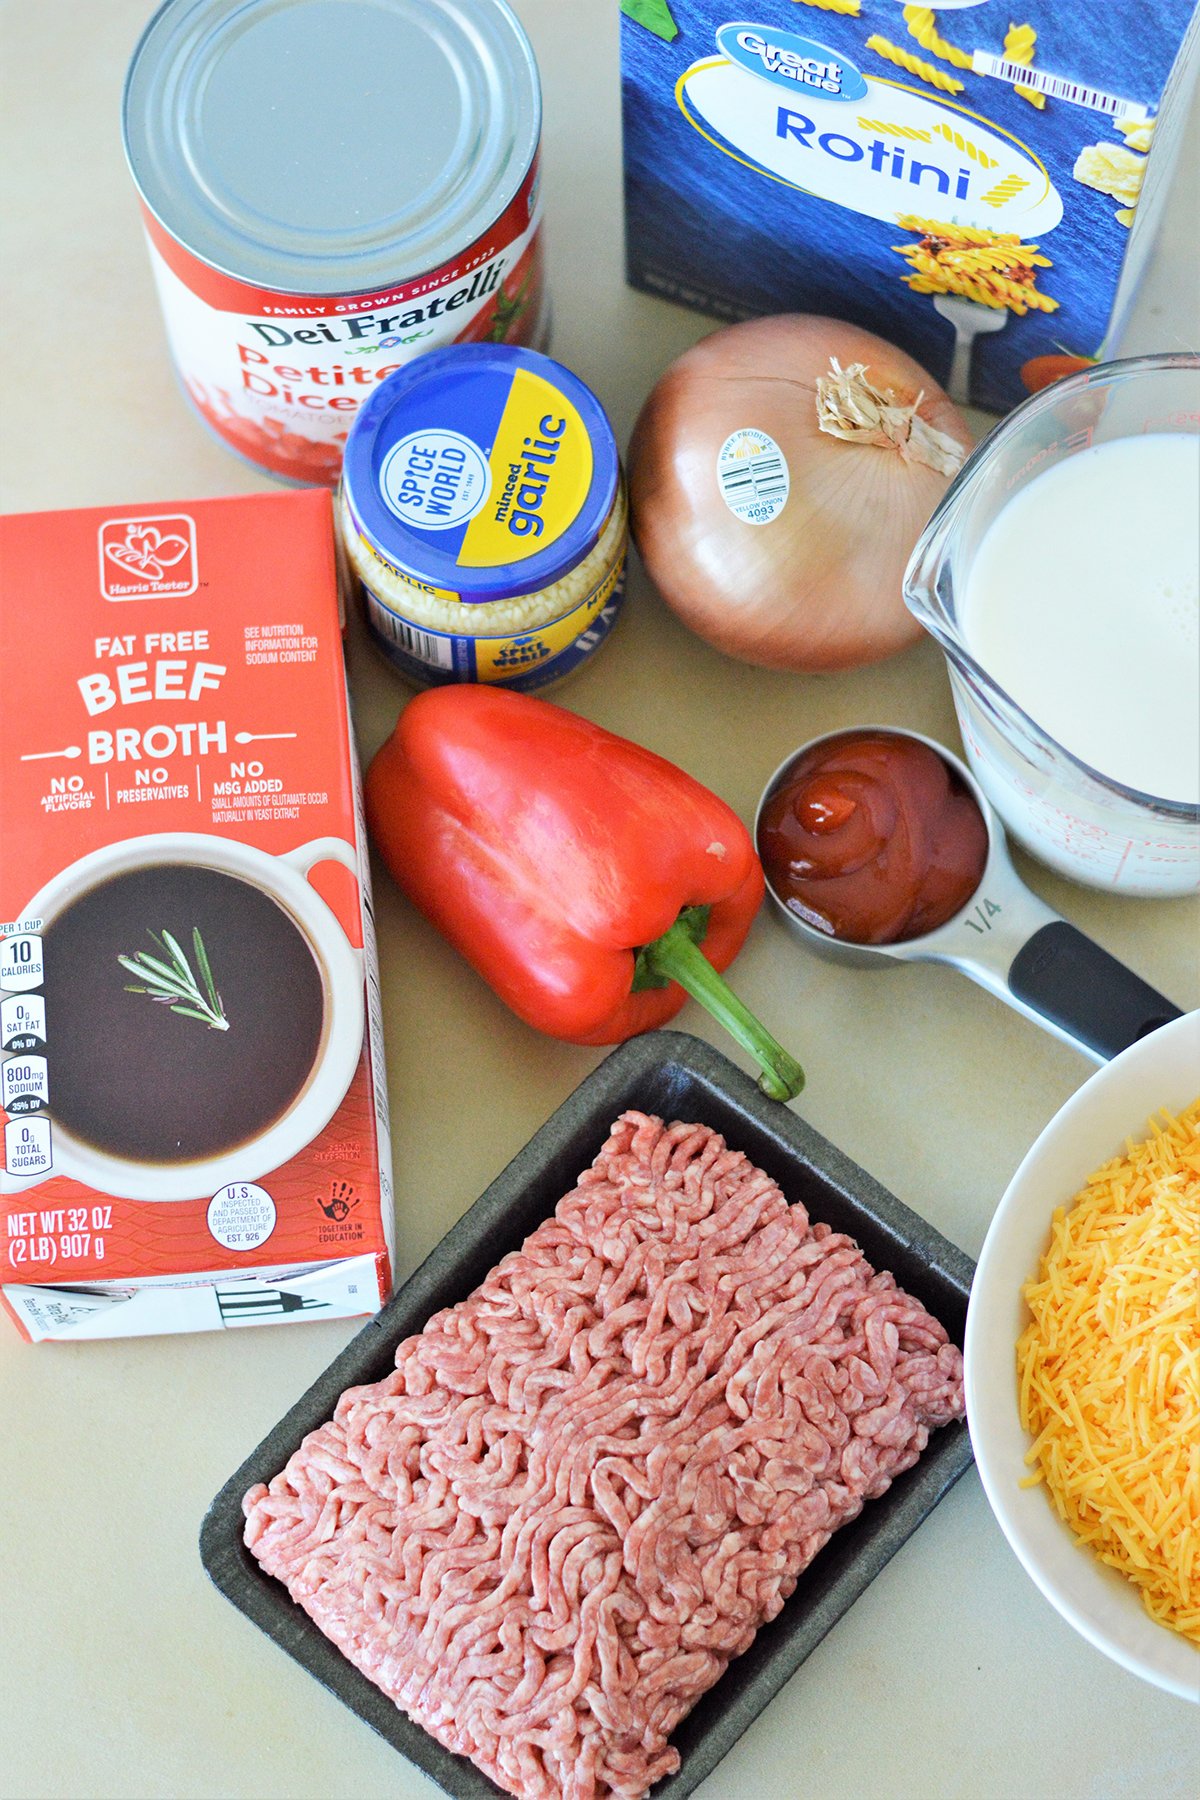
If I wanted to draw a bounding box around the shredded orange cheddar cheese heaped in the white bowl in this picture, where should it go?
[1016,1100,1200,1643]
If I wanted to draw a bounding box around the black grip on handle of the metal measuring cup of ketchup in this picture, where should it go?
[1007,918,1180,1058]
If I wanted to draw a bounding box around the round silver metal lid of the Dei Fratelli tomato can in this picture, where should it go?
[124,0,542,295]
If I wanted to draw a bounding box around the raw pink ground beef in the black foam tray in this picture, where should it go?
[245,1112,963,1800]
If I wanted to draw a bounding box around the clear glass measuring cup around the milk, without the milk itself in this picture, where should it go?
[905,353,1200,895]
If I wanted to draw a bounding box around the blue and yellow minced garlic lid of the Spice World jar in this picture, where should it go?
[342,344,621,605]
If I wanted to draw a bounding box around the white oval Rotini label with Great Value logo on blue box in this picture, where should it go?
[675,20,1063,236]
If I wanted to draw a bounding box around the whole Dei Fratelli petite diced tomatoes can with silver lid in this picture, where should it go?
[124,0,547,484]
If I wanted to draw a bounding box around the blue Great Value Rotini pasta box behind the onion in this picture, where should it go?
[622,0,1200,410]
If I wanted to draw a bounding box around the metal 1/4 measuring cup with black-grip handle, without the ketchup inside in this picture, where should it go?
[754,725,1180,1062]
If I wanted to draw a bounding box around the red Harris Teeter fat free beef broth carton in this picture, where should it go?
[0,490,392,1341]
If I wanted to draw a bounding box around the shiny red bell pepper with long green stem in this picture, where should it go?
[367,686,804,1100]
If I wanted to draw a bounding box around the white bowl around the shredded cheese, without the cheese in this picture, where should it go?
[966,1012,1200,1701]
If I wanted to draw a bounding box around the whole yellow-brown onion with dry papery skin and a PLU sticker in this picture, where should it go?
[630,313,972,670]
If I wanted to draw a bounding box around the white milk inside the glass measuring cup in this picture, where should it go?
[959,432,1200,805]
